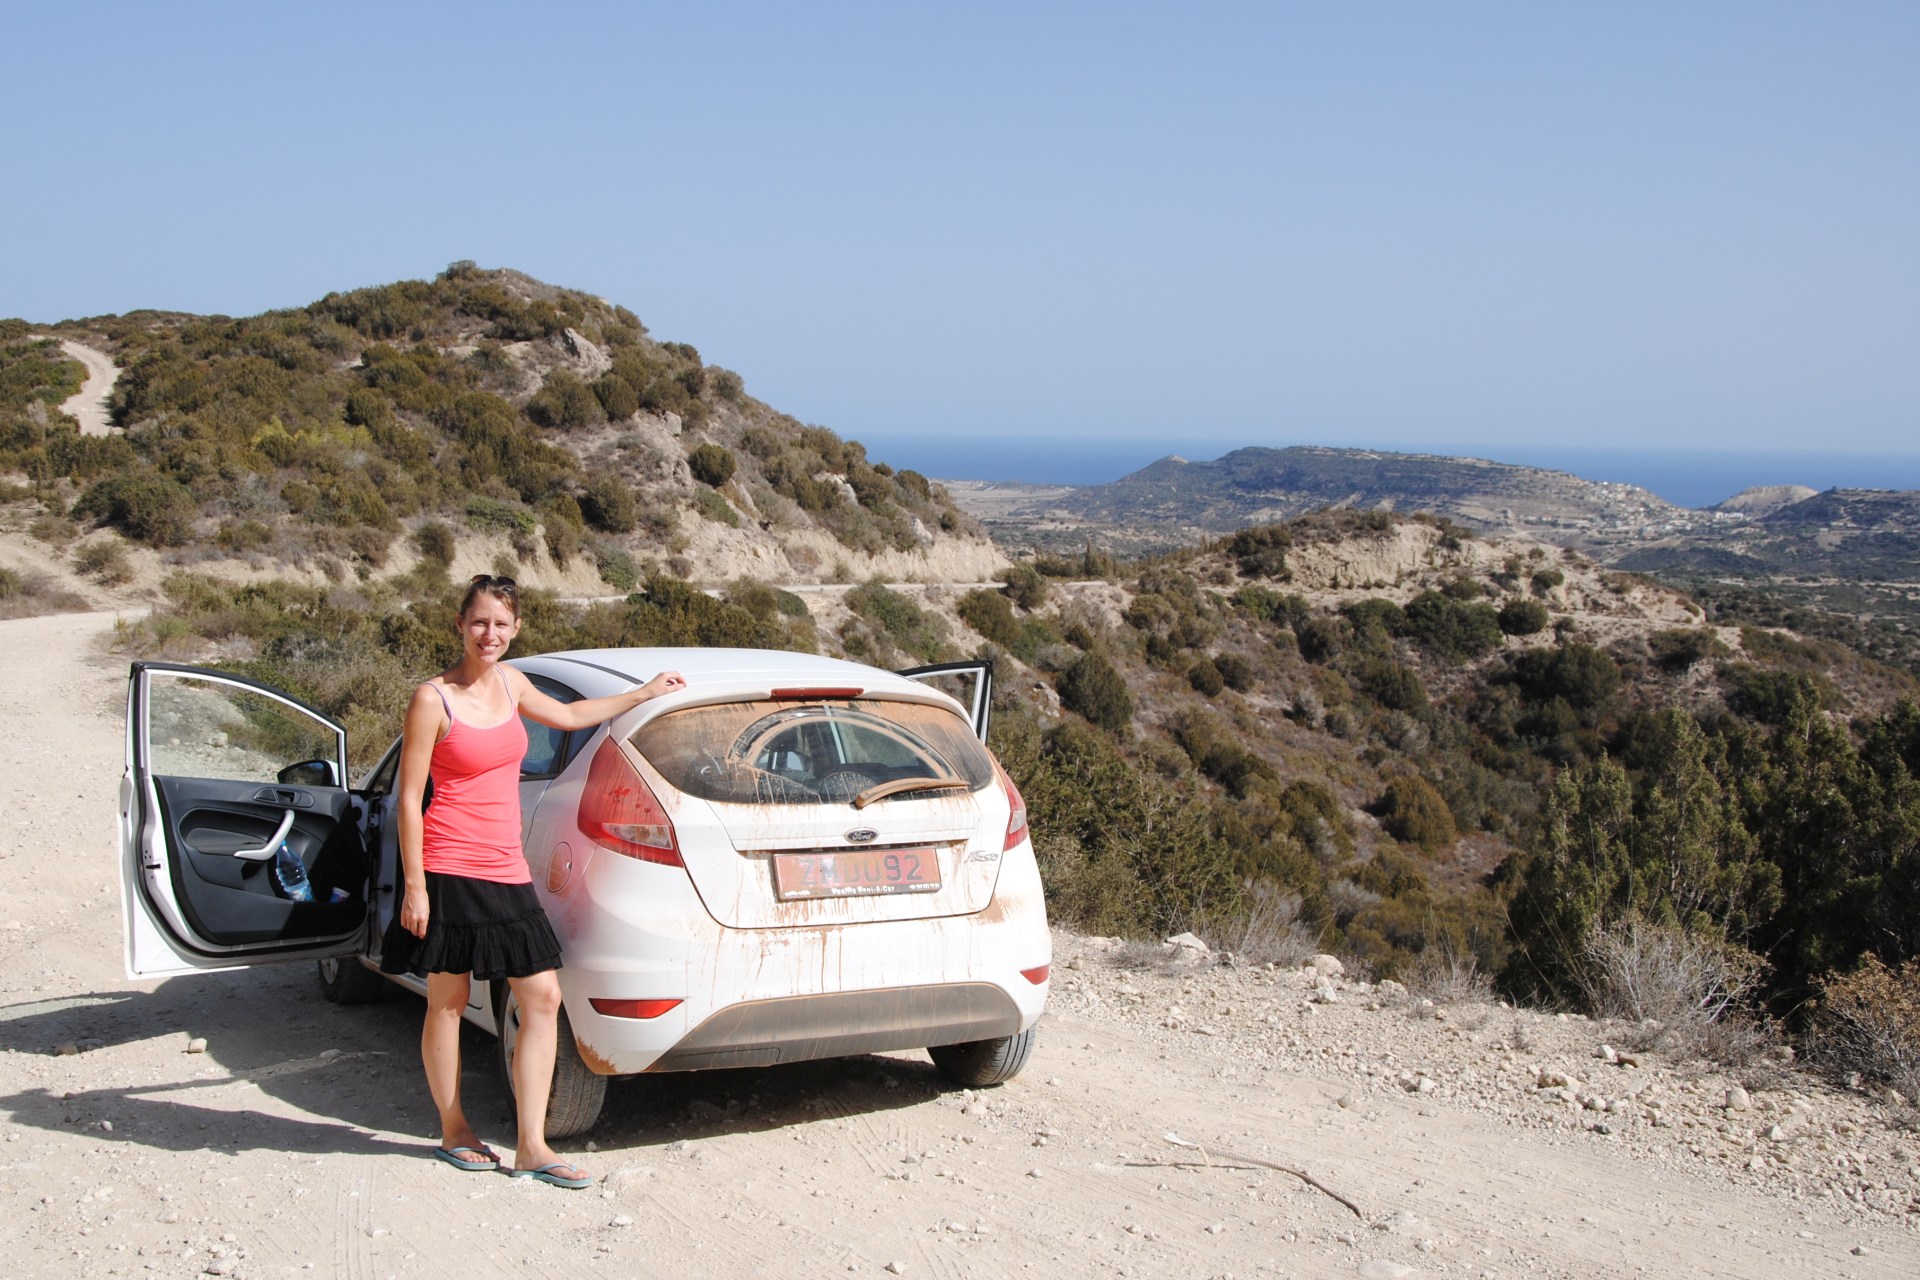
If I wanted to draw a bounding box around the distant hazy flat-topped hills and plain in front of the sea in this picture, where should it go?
[950,447,1920,672]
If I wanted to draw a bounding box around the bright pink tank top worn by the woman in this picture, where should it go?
[420,676,534,885]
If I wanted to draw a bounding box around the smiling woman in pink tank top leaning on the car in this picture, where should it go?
[380,574,687,1188]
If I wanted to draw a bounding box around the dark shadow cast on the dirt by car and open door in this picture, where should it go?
[0,963,958,1153]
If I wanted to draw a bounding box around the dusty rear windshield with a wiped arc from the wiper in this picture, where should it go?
[634,699,993,804]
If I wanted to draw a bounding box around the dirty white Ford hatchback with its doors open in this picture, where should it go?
[119,649,1050,1136]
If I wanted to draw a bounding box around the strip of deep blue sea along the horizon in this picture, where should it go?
[858,436,1920,507]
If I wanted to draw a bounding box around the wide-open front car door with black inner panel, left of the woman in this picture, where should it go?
[119,662,369,977]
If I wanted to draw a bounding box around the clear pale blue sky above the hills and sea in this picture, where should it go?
[0,2,1920,453]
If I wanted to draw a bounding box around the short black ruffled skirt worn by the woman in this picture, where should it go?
[380,871,561,983]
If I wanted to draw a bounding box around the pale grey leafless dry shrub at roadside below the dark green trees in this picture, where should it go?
[1584,919,1778,1067]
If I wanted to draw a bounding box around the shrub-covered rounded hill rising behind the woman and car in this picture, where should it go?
[0,263,1004,595]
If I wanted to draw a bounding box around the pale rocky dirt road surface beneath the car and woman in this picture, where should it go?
[0,614,1920,1278]
